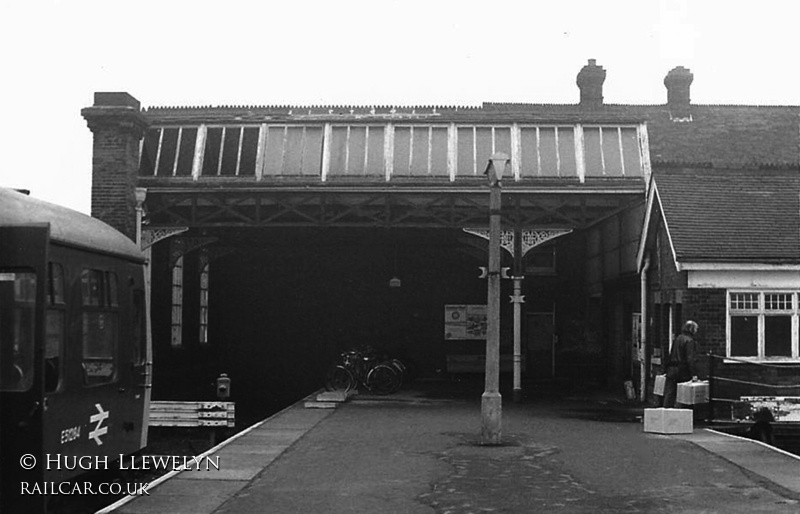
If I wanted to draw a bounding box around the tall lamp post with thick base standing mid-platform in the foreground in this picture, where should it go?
[481,152,510,444]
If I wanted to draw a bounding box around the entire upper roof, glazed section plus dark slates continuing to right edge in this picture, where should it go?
[141,97,800,180]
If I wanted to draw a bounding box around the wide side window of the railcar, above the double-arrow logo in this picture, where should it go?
[81,269,119,385]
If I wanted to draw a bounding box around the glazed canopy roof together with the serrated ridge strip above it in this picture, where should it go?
[140,107,648,182]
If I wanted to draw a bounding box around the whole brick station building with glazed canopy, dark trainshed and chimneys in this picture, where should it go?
[82,60,800,414]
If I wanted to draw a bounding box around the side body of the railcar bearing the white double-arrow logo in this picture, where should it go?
[38,245,147,481]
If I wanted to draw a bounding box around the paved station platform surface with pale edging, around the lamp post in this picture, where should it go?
[100,381,800,514]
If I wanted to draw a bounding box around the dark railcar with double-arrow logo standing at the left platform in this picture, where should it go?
[0,188,151,512]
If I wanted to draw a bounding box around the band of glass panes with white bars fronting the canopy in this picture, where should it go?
[140,122,647,183]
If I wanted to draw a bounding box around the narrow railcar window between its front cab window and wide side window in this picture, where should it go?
[44,262,66,392]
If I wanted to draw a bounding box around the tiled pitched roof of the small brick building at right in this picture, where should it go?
[653,168,800,264]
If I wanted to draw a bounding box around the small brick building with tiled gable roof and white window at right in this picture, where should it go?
[638,166,800,410]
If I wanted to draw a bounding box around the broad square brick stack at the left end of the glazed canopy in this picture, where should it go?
[81,93,147,241]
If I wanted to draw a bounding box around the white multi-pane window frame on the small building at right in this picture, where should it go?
[725,289,800,362]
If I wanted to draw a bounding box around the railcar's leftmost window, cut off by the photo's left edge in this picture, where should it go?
[0,270,36,391]
